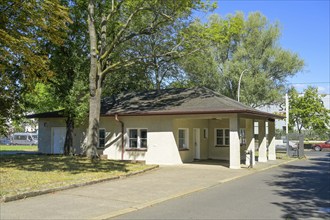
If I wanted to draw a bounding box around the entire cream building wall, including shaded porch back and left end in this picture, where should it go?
[39,116,250,164]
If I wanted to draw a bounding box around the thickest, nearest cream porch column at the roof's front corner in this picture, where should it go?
[229,116,241,169]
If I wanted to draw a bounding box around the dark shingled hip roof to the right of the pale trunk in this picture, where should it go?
[101,87,281,119]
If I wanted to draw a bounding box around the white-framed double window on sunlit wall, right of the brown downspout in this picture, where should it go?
[128,129,148,148]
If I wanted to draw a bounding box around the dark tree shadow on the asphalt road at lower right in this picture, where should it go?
[268,153,330,219]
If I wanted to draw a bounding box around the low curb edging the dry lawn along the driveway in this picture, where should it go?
[0,165,159,203]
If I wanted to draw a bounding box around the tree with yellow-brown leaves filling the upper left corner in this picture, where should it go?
[0,0,71,133]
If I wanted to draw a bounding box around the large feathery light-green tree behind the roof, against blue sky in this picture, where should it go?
[182,12,304,107]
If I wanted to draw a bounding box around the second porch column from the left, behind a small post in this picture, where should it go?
[245,119,256,166]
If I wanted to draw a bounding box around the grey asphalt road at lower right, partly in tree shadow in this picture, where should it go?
[116,151,330,219]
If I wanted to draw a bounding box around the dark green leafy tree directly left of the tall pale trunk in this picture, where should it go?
[25,0,89,155]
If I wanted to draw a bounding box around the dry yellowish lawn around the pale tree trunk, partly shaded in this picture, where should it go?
[0,155,152,198]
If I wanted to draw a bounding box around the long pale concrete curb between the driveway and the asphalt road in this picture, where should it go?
[91,158,299,220]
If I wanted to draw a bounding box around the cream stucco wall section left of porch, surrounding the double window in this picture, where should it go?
[100,116,182,164]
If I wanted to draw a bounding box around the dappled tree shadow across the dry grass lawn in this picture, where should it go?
[0,155,128,174]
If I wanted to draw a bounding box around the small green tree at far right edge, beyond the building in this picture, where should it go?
[289,87,330,133]
